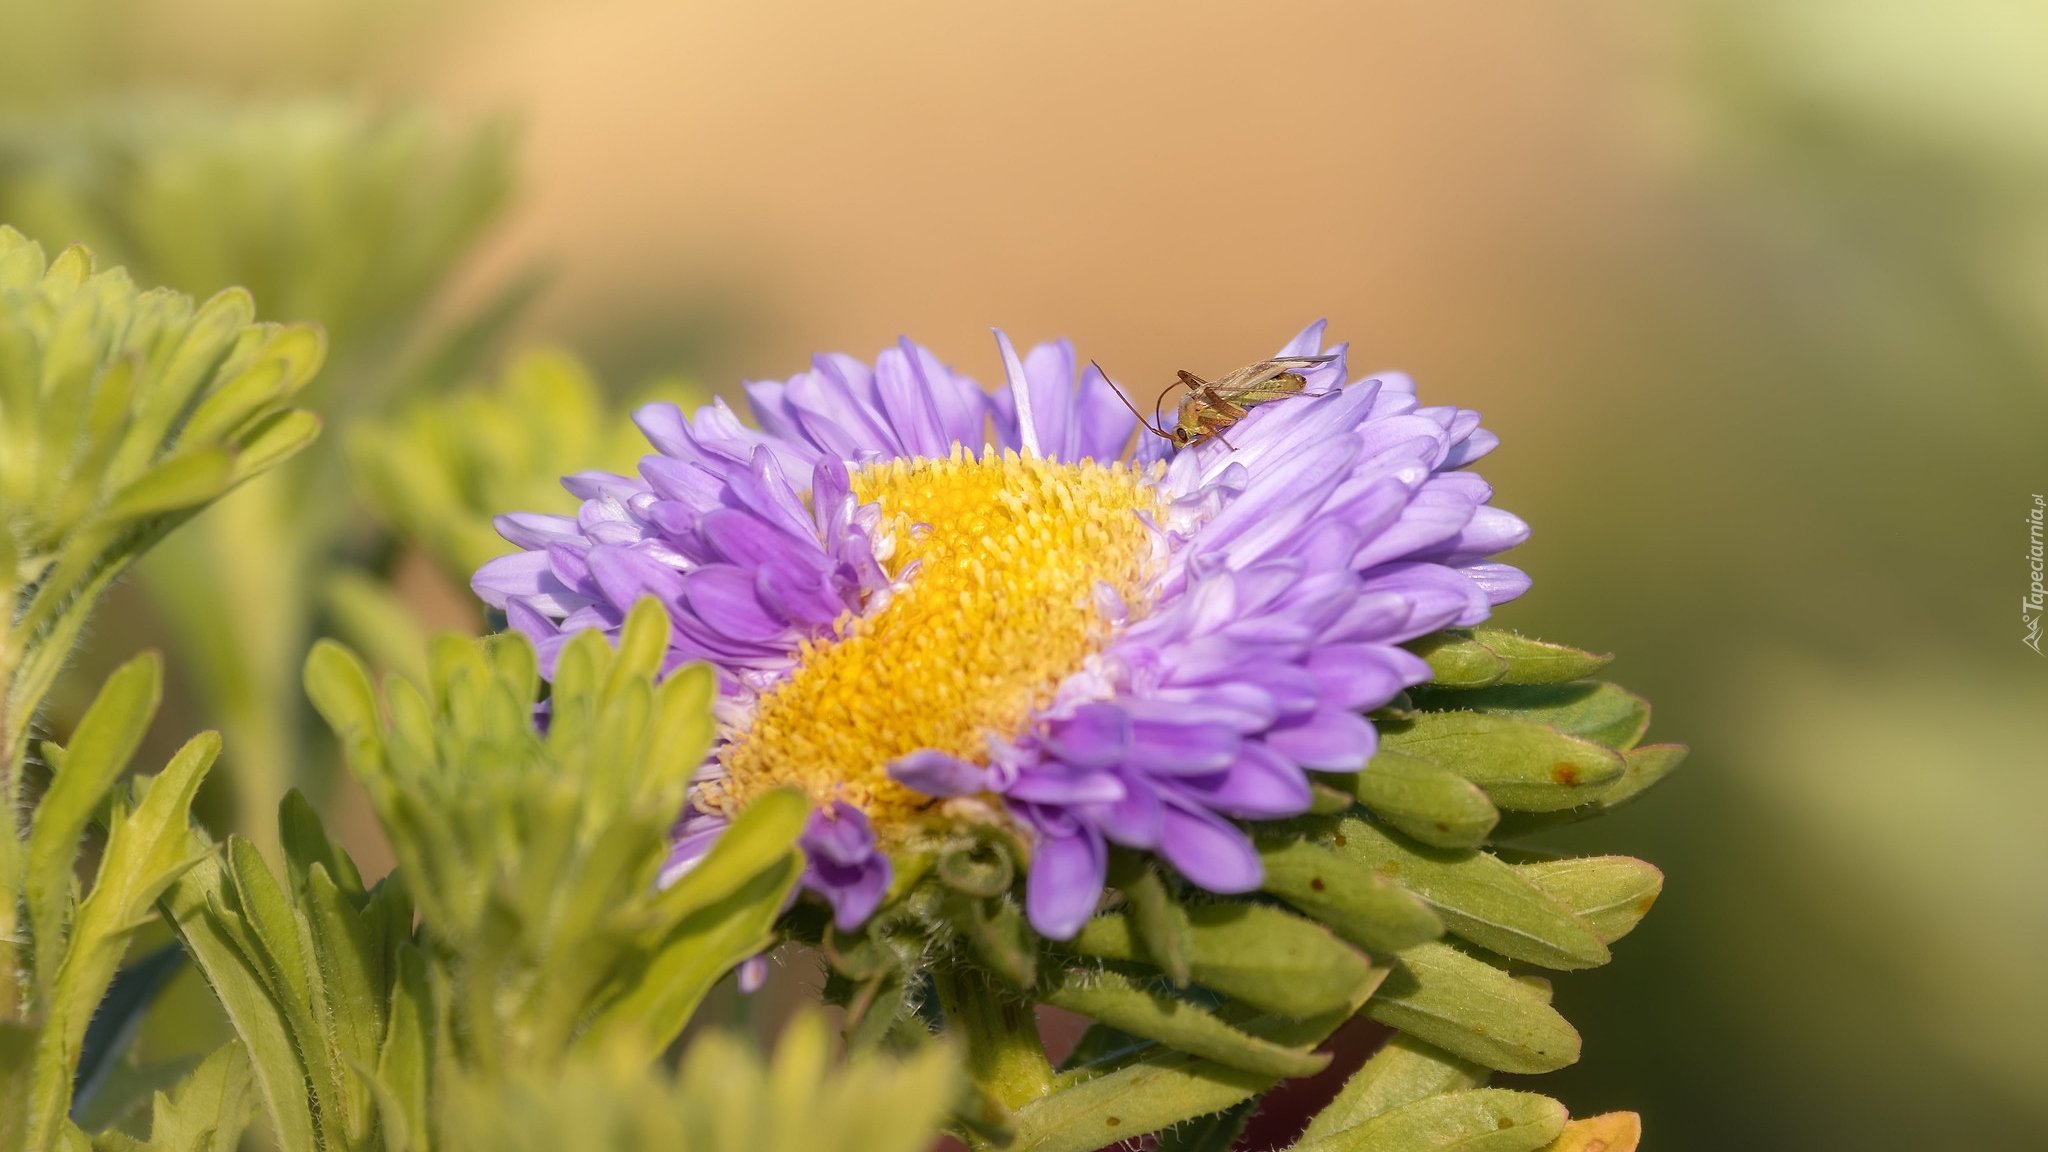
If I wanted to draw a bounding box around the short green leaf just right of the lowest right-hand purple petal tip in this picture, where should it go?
[1257,830,1444,953]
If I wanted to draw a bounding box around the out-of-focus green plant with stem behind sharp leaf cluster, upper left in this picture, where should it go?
[0,98,537,851]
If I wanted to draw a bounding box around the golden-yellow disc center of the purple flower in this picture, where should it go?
[707,449,1161,828]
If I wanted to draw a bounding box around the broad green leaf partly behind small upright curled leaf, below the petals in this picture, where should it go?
[1073,902,1378,1016]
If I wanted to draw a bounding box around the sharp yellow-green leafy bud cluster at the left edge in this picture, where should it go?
[0,225,326,763]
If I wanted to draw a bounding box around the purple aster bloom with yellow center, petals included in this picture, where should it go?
[475,322,1528,939]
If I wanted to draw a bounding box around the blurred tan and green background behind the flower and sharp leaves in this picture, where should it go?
[0,0,2048,1150]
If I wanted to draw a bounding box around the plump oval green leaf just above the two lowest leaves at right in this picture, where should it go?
[1366,943,1579,1074]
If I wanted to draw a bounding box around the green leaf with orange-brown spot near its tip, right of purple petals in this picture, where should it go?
[1380,711,1624,812]
